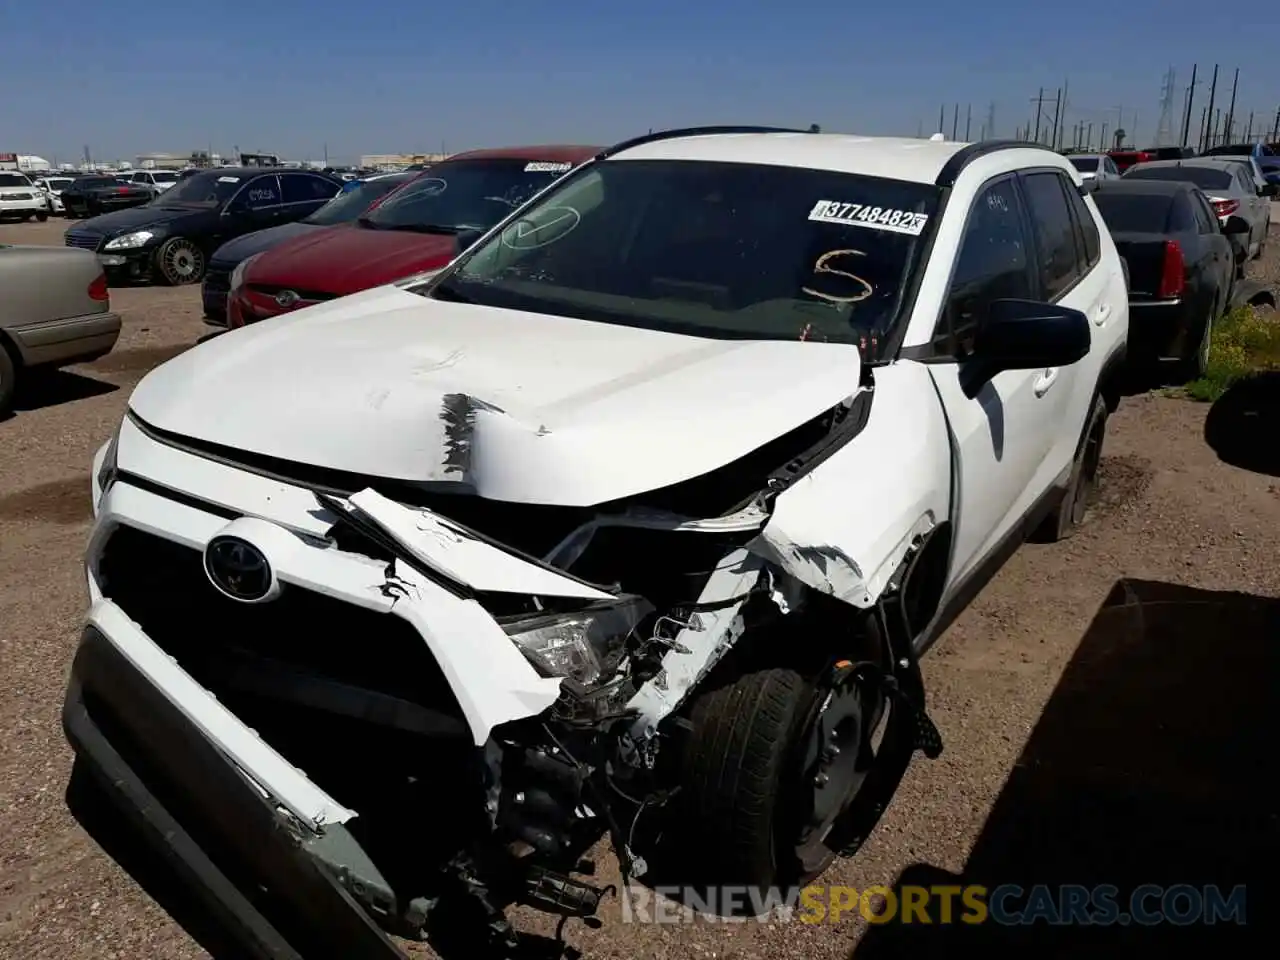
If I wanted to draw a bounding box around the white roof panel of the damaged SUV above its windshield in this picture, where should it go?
[611,132,998,184]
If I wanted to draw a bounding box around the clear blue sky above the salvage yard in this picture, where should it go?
[0,0,1280,161]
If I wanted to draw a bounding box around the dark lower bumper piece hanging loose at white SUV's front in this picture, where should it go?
[63,623,404,960]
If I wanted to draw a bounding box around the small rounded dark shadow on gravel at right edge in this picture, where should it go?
[1204,371,1280,476]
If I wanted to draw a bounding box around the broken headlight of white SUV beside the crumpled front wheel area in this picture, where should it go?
[504,596,653,686]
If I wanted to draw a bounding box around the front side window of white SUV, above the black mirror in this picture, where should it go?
[937,177,1034,356]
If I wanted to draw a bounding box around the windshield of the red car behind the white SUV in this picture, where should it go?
[362,157,570,233]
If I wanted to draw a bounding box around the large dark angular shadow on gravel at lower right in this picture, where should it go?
[851,580,1280,960]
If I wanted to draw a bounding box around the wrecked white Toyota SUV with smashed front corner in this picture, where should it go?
[64,128,1128,957]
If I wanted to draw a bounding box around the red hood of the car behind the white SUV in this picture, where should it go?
[244,225,457,296]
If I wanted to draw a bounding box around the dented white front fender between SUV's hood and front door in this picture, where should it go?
[749,364,951,608]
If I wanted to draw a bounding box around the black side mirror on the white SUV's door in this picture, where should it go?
[973,300,1089,378]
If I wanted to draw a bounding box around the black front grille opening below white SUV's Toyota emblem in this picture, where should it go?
[99,526,461,716]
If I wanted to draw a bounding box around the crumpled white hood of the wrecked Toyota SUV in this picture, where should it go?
[129,287,859,506]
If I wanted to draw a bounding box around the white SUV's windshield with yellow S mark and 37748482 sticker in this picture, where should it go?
[422,160,940,344]
